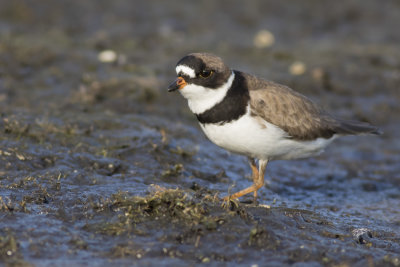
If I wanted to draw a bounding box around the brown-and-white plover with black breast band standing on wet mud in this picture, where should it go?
[168,53,380,200]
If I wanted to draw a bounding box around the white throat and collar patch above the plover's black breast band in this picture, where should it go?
[179,72,235,114]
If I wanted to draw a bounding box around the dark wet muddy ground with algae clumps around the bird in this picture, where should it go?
[0,0,400,266]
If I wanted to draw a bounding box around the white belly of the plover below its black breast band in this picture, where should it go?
[200,112,335,160]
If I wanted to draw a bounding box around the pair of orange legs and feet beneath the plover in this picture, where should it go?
[224,159,268,201]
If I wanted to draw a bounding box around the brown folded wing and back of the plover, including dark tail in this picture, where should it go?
[246,72,379,140]
